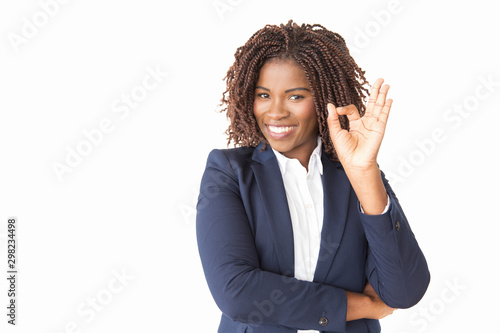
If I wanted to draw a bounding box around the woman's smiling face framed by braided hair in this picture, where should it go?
[253,59,318,167]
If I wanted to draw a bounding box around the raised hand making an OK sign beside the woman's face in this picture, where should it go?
[327,78,392,171]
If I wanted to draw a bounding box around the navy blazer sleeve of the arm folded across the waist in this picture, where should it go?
[196,150,347,332]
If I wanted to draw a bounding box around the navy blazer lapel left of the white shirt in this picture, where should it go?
[251,142,294,276]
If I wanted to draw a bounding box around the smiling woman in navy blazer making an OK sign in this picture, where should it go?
[197,21,430,333]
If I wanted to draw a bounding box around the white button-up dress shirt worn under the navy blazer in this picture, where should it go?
[273,136,389,333]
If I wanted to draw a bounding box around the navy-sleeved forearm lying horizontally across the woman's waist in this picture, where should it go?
[201,269,347,332]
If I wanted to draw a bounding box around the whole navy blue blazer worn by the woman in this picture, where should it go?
[196,143,430,333]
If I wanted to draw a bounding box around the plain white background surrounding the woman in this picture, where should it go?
[0,0,500,333]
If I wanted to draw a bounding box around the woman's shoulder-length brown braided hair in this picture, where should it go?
[221,20,368,160]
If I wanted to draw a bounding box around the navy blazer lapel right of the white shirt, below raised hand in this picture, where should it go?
[314,152,351,282]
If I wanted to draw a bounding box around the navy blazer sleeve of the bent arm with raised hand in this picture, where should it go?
[360,172,430,309]
